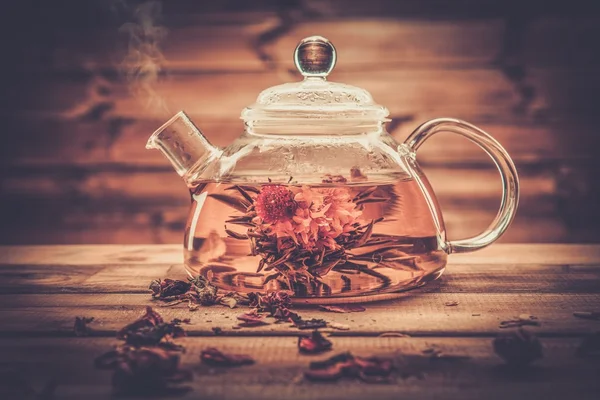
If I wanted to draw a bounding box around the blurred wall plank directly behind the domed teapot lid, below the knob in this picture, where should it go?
[12,68,600,126]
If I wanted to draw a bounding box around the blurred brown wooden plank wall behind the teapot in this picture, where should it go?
[0,0,600,244]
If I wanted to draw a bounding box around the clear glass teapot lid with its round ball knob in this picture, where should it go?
[241,36,389,129]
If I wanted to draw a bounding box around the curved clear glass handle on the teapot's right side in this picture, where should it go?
[402,118,519,253]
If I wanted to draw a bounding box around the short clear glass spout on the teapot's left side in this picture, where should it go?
[146,111,222,179]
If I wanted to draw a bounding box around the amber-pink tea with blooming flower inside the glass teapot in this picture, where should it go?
[184,178,447,304]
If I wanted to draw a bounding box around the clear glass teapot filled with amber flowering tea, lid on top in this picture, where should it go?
[146,36,519,304]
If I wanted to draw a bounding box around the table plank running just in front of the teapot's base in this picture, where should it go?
[0,292,600,336]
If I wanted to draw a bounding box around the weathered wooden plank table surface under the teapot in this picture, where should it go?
[0,244,600,399]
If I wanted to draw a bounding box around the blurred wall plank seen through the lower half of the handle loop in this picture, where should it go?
[0,167,556,211]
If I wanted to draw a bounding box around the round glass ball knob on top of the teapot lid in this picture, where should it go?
[294,36,337,78]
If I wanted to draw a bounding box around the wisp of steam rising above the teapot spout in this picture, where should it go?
[119,1,168,113]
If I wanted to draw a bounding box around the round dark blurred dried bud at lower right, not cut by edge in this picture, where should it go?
[493,328,543,366]
